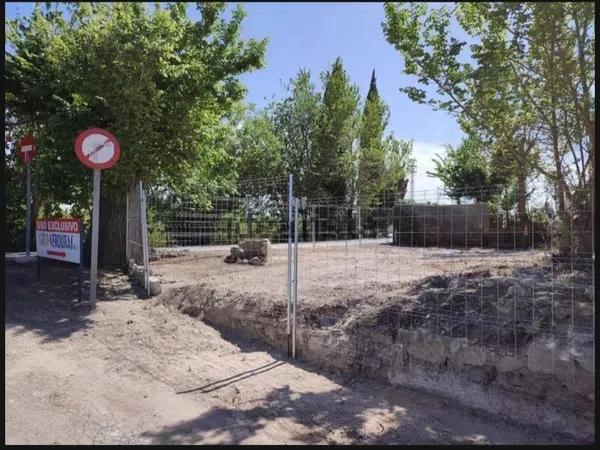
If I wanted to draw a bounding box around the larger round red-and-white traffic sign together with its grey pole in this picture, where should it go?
[75,128,121,303]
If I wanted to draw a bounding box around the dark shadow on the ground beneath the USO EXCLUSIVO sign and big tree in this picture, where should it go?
[5,260,145,342]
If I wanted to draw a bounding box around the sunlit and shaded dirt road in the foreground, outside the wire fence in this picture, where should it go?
[5,263,575,444]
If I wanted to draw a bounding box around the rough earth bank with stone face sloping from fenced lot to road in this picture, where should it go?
[158,268,595,442]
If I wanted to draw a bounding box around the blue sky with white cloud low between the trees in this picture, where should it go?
[6,2,462,195]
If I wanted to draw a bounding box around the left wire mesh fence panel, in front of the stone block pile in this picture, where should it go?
[148,177,289,350]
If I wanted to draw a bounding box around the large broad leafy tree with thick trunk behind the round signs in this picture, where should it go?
[4,3,266,263]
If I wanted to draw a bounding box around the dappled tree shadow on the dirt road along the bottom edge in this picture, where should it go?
[142,382,577,445]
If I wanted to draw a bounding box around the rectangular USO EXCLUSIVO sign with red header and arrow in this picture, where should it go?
[35,218,81,263]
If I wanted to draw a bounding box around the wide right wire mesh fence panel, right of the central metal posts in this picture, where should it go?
[298,187,595,422]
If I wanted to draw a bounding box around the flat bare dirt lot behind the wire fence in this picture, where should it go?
[150,243,544,304]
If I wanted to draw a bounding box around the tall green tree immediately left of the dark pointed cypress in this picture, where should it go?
[313,58,359,200]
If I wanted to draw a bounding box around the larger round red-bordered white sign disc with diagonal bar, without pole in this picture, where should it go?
[75,128,121,169]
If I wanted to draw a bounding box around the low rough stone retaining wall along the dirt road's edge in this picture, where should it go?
[166,286,595,438]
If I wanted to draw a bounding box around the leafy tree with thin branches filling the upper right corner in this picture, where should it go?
[383,2,595,218]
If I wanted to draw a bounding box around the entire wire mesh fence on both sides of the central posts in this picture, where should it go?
[143,178,595,388]
